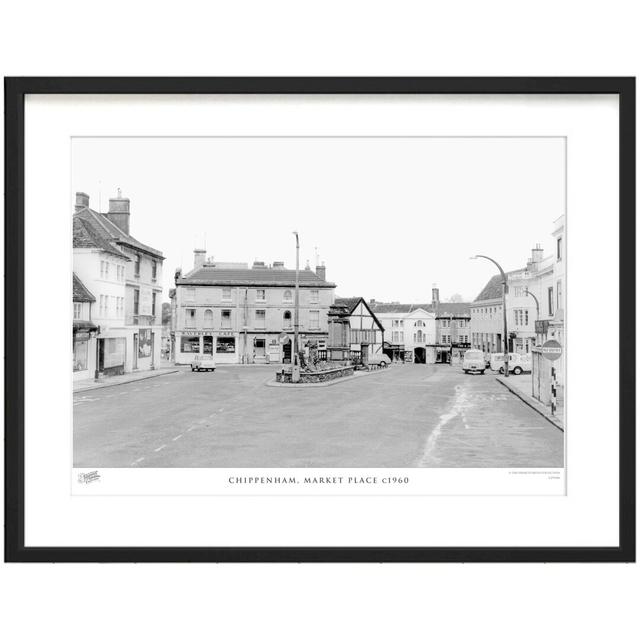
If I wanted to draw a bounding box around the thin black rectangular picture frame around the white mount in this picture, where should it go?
[5,77,636,562]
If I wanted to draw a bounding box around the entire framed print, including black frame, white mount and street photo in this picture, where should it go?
[7,78,634,562]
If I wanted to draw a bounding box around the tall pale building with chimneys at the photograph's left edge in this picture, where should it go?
[73,192,164,375]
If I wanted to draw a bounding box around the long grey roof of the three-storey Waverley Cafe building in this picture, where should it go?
[176,263,336,289]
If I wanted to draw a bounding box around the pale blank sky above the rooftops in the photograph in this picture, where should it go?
[71,137,566,303]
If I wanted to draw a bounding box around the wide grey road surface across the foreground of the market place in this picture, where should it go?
[73,365,564,468]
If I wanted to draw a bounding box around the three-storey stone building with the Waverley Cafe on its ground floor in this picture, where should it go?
[170,255,336,364]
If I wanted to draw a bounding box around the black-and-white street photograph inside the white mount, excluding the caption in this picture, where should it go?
[69,136,571,469]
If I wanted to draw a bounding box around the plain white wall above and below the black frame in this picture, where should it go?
[0,0,640,640]
